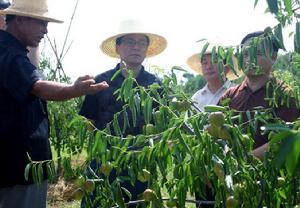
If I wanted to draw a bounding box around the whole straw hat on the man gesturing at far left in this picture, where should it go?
[0,0,63,23]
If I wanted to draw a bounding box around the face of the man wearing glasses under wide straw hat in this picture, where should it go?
[116,34,148,67]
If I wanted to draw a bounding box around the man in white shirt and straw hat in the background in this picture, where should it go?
[187,44,240,111]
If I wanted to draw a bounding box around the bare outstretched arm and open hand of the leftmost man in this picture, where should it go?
[31,75,108,101]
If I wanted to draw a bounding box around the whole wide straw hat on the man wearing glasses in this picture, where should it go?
[100,20,167,58]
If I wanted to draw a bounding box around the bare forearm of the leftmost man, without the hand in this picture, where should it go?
[32,80,83,101]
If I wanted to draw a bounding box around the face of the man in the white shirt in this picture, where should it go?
[201,54,224,81]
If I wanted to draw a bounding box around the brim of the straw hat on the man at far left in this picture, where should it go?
[0,8,64,23]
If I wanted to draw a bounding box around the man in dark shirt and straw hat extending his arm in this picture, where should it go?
[0,0,107,208]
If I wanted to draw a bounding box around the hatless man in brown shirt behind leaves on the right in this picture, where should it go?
[221,31,300,159]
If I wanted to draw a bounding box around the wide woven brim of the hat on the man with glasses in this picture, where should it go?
[100,32,167,58]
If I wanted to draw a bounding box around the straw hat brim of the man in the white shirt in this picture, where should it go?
[187,53,242,80]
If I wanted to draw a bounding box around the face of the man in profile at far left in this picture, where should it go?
[17,17,48,47]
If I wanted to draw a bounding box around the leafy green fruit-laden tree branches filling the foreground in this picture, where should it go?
[61,70,300,207]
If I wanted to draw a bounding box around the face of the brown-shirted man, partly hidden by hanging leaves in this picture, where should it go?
[243,39,276,76]
